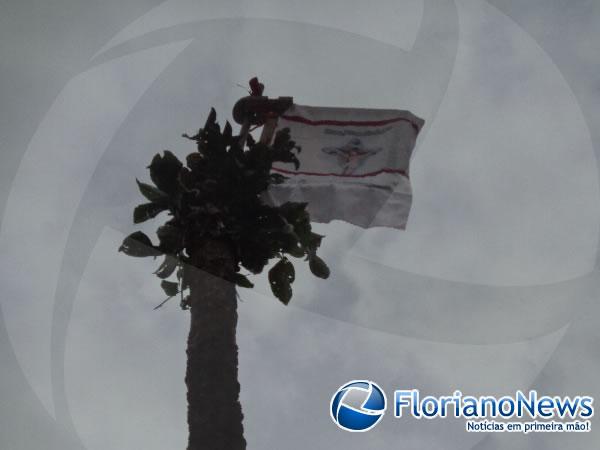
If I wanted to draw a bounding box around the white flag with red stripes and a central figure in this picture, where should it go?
[268,105,424,229]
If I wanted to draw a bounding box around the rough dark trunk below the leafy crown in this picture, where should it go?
[185,241,246,450]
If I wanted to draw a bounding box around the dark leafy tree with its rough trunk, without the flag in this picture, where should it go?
[119,99,329,450]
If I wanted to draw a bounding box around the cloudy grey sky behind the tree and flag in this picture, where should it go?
[0,0,600,450]
